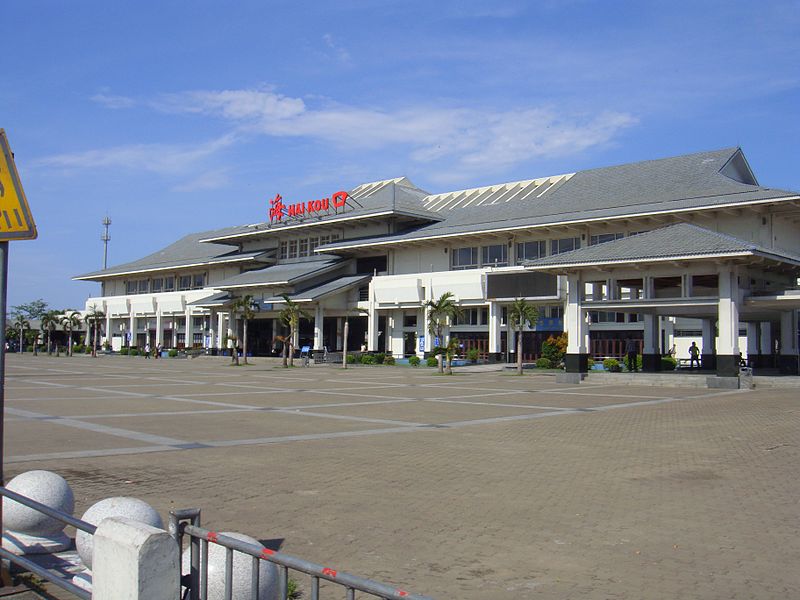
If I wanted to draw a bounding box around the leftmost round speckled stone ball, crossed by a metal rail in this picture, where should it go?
[3,471,75,537]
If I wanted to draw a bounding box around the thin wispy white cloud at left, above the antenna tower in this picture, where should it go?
[34,134,236,175]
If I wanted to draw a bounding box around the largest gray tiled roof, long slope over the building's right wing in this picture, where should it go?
[318,148,797,251]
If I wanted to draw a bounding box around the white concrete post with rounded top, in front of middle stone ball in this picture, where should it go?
[92,517,181,600]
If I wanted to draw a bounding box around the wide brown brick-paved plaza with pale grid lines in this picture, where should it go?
[1,355,800,600]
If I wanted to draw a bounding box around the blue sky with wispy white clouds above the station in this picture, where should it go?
[0,0,800,308]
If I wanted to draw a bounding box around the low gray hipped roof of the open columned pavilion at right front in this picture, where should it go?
[524,223,800,269]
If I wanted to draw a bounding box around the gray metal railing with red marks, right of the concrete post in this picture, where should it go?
[169,508,431,600]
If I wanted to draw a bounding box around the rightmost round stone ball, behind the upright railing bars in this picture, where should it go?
[183,531,279,600]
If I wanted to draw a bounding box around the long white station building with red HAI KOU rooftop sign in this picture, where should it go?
[76,148,800,376]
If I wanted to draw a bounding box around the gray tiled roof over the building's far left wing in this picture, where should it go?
[74,230,264,279]
